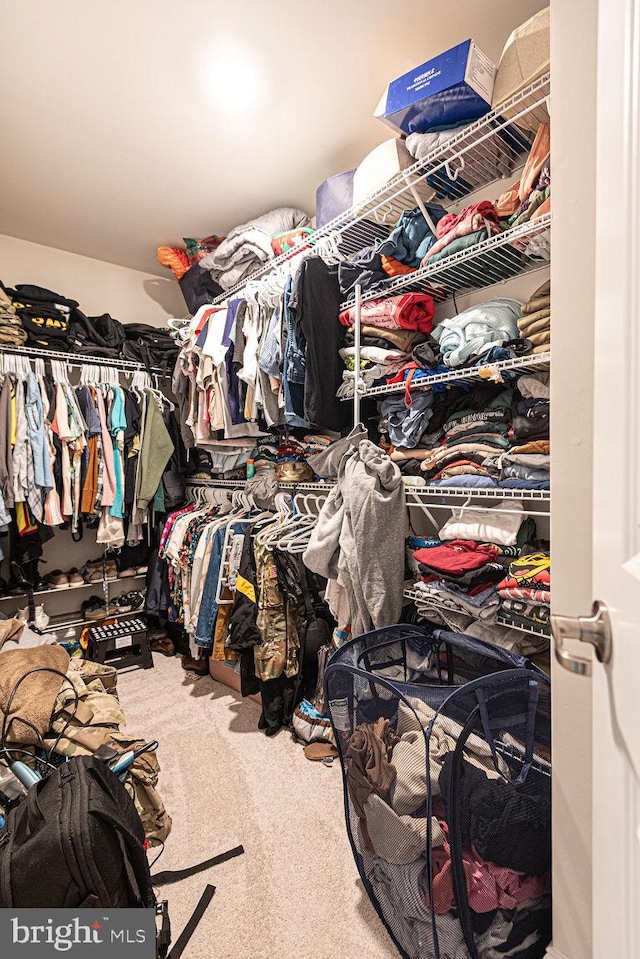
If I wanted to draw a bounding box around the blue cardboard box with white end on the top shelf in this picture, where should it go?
[374,40,496,134]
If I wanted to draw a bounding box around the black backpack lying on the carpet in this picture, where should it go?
[0,756,156,909]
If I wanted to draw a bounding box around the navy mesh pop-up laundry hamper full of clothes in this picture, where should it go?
[325,625,551,959]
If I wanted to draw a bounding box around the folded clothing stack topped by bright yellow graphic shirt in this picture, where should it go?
[497,551,551,632]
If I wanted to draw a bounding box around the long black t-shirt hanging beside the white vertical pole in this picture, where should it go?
[289,256,348,430]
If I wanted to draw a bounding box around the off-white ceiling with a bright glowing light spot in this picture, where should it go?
[0,0,546,276]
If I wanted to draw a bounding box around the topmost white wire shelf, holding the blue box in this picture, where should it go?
[213,74,550,305]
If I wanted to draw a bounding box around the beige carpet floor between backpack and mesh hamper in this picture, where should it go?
[118,655,398,959]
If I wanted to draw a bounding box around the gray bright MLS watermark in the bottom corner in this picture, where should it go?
[0,909,156,959]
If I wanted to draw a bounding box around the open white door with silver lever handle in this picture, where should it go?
[577,0,640,959]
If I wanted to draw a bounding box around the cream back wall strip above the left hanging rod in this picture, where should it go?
[0,234,188,326]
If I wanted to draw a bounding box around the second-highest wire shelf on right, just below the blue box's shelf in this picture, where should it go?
[340,213,551,312]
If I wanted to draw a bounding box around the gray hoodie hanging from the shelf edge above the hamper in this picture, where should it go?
[303,440,407,636]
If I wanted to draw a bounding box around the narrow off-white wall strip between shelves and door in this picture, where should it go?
[551,0,598,959]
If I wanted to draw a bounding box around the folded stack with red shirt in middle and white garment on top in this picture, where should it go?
[414,500,535,629]
